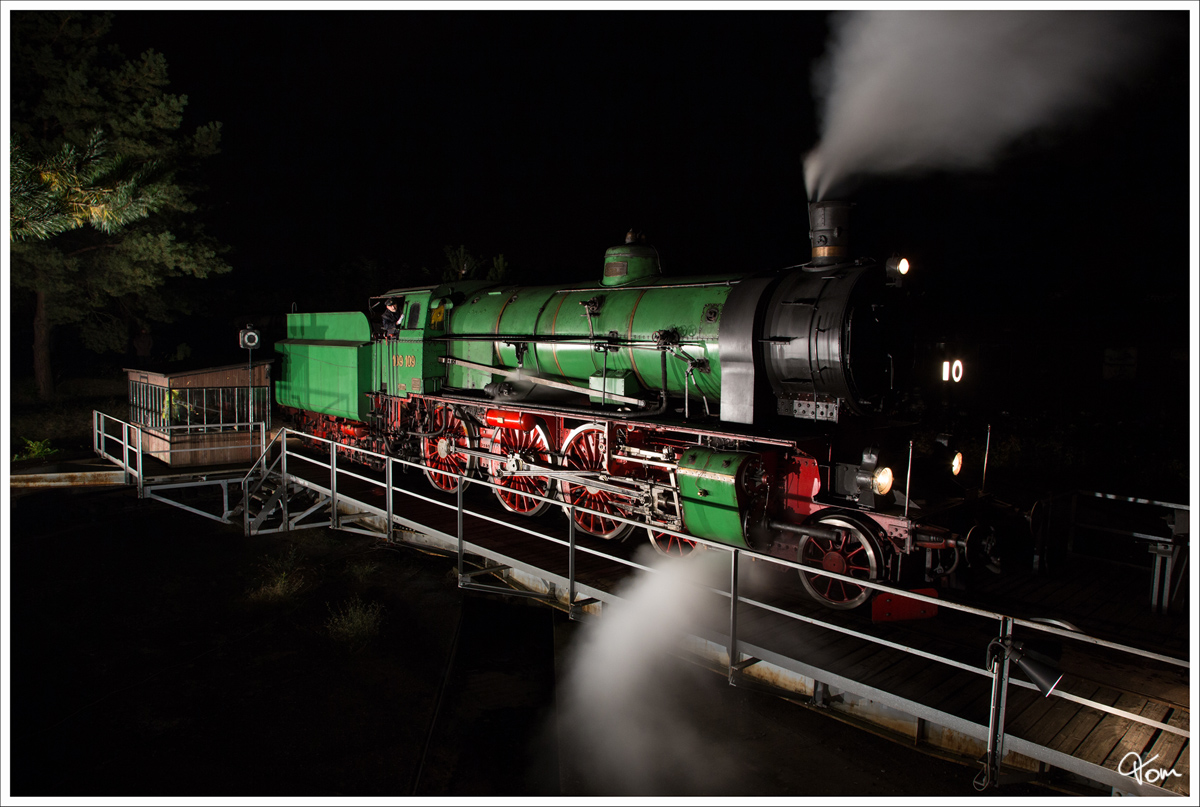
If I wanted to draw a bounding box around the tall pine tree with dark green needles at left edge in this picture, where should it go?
[10,11,229,399]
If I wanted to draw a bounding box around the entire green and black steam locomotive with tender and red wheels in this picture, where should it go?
[275,202,998,609]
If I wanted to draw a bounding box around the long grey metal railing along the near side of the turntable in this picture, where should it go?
[280,430,1190,795]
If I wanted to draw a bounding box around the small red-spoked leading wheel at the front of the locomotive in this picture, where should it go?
[799,515,883,610]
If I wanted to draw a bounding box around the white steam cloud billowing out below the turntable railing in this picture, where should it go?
[558,550,738,796]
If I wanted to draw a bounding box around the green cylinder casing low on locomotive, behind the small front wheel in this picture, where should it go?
[678,446,756,549]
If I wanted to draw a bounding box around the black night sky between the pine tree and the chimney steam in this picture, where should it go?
[114,11,826,290]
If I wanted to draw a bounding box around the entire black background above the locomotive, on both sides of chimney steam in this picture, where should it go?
[14,10,1195,496]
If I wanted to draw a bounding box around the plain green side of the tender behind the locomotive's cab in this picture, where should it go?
[275,311,371,422]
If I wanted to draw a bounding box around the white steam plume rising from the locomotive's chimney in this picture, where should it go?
[804,11,1157,199]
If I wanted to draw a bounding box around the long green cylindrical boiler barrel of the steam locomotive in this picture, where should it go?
[434,275,740,405]
